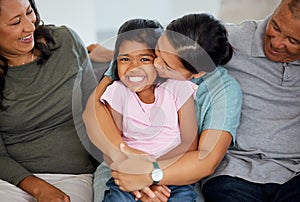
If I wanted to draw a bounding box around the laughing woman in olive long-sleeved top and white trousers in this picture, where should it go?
[0,0,97,202]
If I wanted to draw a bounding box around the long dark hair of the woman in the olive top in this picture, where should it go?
[0,0,55,110]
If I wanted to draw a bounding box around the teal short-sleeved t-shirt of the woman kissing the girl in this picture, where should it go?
[104,65,242,144]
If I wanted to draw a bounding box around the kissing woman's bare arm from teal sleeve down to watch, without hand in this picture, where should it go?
[160,130,232,185]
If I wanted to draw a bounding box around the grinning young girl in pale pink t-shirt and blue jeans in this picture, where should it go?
[101,19,197,201]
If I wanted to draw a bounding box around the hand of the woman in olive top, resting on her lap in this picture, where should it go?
[18,175,71,202]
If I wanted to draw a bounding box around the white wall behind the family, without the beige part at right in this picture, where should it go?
[36,0,219,44]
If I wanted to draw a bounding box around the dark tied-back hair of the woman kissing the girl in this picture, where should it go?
[166,13,233,73]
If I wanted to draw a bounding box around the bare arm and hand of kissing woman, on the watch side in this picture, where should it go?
[112,130,232,191]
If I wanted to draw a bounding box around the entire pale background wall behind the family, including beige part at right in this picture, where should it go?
[36,0,280,45]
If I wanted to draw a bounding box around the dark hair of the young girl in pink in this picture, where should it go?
[112,18,163,80]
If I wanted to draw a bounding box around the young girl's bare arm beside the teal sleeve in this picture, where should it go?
[159,96,198,160]
